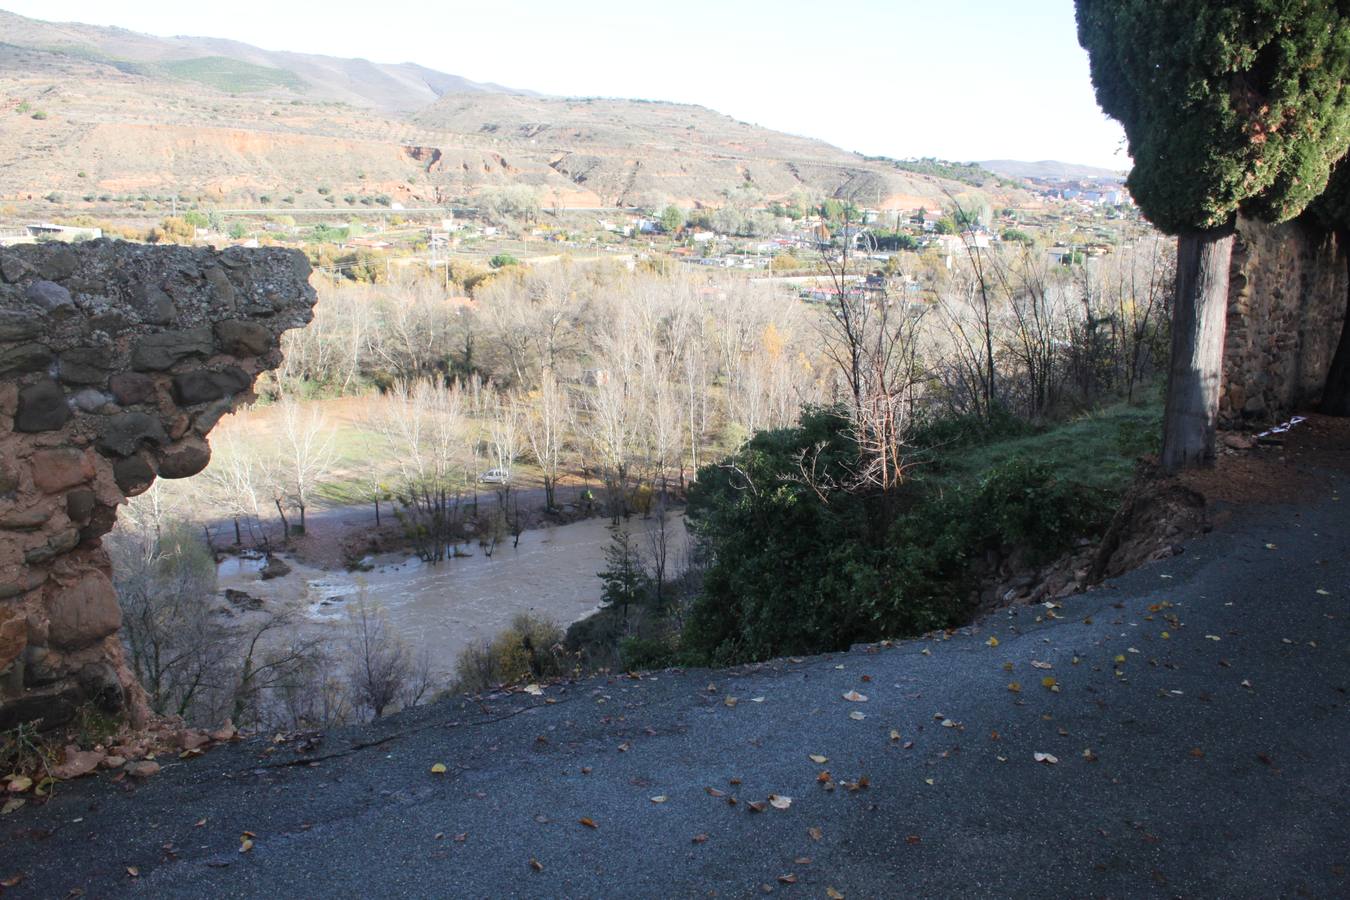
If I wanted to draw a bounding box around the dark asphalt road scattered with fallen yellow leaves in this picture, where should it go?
[0,475,1350,897]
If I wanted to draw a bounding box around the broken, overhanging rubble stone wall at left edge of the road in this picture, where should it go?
[0,240,315,729]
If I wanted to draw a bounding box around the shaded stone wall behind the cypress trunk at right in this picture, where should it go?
[1219,219,1347,426]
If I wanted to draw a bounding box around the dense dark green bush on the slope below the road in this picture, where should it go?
[683,410,1116,664]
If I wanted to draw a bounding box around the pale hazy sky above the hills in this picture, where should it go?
[0,0,1129,169]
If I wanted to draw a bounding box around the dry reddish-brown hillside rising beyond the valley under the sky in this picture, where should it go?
[0,12,1004,213]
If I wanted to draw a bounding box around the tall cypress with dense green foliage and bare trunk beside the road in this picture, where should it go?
[1076,0,1350,472]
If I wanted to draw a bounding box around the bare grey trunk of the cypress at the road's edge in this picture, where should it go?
[1162,228,1234,472]
